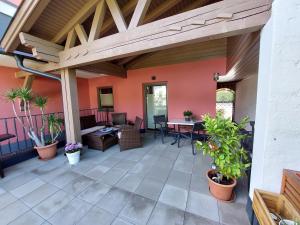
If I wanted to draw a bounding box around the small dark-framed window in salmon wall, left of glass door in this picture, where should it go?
[97,87,114,111]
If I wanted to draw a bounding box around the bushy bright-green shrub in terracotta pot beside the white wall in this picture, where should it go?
[196,112,250,201]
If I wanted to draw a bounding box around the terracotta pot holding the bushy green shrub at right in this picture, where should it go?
[206,170,237,201]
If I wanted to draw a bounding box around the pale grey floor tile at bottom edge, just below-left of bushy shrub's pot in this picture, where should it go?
[186,191,219,222]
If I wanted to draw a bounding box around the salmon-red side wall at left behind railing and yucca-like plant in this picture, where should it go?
[0,67,90,118]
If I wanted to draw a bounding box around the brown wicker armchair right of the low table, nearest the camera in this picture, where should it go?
[119,117,143,151]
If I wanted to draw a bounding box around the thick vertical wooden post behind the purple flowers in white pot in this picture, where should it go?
[61,68,81,143]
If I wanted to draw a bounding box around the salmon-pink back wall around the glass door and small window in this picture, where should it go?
[89,58,226,124]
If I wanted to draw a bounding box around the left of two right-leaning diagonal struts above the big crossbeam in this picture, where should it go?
[88,0,106,42]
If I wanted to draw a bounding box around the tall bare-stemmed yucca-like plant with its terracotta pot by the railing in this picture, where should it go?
[5,88,63,160]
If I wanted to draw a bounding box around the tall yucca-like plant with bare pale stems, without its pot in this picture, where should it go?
[5,88,62,147]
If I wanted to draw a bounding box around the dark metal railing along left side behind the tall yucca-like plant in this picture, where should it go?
[0,108,110,167]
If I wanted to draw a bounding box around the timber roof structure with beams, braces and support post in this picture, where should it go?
[1,0,272,142]
